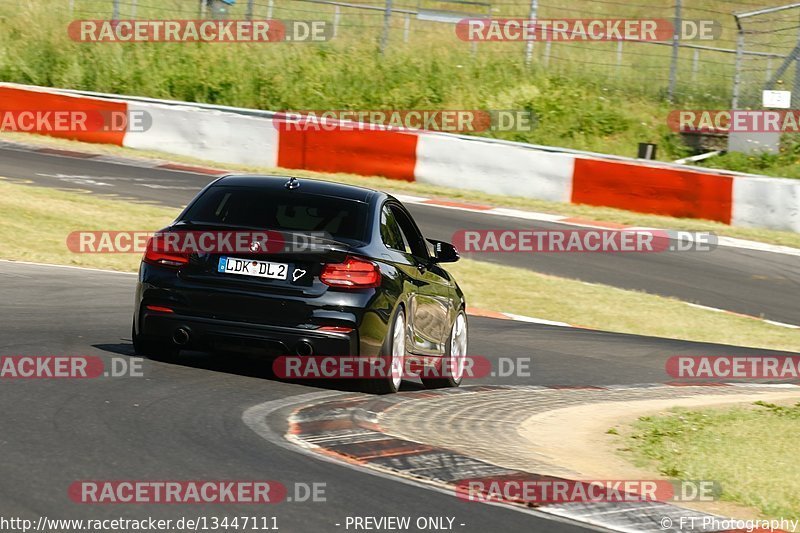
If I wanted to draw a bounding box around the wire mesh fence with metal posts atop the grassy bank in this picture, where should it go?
[70,0,800,108]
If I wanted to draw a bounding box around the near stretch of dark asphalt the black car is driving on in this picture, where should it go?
[0,261,792,533]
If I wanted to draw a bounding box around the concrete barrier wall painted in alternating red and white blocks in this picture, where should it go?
[0,84,800,232]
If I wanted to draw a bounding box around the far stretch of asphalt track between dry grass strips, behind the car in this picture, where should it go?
[0,141,800,324]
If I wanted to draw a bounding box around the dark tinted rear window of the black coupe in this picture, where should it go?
[182,186,368,242]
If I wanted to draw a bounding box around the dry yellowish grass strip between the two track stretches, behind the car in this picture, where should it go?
[0,181,800,351]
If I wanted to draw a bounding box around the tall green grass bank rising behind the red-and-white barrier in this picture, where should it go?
[0,0,795,176]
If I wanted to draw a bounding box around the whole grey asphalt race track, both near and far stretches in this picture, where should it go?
[0,142,800,533]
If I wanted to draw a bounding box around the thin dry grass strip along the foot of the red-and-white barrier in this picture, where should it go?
[0,132,800,248]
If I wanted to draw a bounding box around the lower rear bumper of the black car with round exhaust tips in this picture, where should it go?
[139,310,359,356]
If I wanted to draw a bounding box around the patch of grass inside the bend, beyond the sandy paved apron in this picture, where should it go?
[627,402,800,520]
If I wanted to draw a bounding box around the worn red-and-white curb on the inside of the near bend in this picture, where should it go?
[280,383,797,533]
